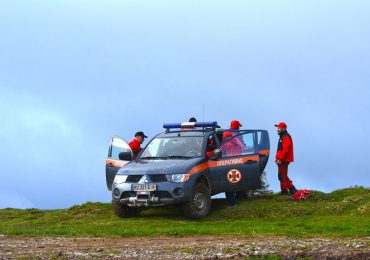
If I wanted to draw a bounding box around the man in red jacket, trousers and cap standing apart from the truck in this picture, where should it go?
[275,122,297,195]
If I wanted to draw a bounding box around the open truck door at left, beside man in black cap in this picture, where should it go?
[105,136,133,190]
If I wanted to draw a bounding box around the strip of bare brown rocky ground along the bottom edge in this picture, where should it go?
[0,235,370,259]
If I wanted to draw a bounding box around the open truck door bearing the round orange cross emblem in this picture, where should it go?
[210,130,260,192]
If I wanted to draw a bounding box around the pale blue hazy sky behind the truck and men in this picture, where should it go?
[0,0,370,209]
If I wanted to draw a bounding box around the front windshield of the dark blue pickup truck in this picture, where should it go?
[140,136,204,160]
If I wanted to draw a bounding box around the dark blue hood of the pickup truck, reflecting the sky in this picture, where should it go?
[117,158,204,175]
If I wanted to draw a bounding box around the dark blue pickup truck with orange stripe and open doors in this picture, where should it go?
[106,122,270,219]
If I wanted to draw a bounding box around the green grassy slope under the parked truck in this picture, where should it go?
[0,187,370,237]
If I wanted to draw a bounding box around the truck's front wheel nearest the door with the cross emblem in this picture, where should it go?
[183,183,211,219]
